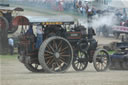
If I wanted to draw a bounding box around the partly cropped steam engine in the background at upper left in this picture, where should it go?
[0,4,24,34]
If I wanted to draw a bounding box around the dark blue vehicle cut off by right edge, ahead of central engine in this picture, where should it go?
[110,37,128,70]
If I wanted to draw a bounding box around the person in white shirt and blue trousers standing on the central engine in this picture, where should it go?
[36,25,44,48]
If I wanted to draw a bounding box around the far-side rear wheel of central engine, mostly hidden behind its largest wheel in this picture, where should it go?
[24,57,44,72]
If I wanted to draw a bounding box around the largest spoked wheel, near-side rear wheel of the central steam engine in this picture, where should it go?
[38,36,73,72]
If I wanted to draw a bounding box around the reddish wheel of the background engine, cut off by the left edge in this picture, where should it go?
[0,16,9,33]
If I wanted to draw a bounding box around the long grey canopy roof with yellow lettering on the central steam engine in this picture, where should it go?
[13,16,74,25]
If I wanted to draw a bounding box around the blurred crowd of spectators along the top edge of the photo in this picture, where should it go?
[8,0,96,16]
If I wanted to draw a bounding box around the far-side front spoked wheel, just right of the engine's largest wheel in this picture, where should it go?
[72,51,88,71]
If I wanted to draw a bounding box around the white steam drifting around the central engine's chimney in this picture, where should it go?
[79,13,119,29]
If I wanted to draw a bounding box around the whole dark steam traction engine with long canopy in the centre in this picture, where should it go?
[14,16,110,72]
